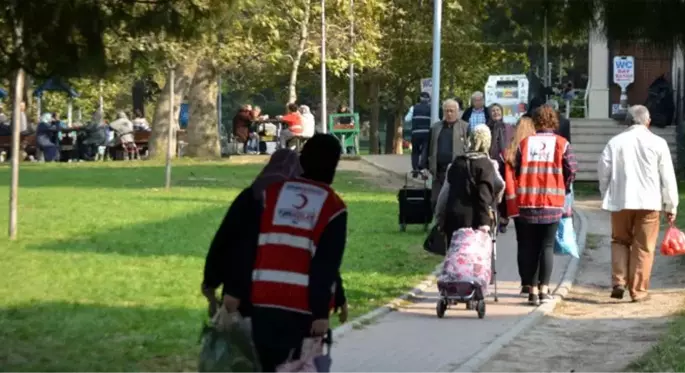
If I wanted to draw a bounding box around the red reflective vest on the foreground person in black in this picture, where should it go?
[252,178,346,314]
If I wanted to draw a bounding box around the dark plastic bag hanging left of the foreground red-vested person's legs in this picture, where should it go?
[198,307,262,373]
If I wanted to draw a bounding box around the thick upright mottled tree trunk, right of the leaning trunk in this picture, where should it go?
[186,60,221,158]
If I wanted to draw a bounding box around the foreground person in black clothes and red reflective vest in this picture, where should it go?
[251,134,347,373]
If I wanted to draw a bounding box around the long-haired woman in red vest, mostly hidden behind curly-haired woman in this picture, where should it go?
[504,117,535,294]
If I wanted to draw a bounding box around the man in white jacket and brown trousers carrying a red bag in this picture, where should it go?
[597,105,678,302]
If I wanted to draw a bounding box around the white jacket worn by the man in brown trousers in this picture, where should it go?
[597,124,678,214]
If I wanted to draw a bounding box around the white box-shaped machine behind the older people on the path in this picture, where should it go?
[485,74,529,124]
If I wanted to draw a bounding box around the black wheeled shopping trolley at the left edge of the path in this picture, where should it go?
[397,174,433,232]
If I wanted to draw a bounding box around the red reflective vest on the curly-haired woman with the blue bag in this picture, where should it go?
[516,133,568,209]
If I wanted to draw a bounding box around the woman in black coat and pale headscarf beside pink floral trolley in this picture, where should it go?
[435,124,504,237]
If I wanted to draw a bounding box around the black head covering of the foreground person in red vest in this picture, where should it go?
[300,133,342,185]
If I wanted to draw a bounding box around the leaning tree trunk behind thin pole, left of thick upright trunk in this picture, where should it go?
[148,61,197,160]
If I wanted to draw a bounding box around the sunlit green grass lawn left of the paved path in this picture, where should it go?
[0,162,438,373]
